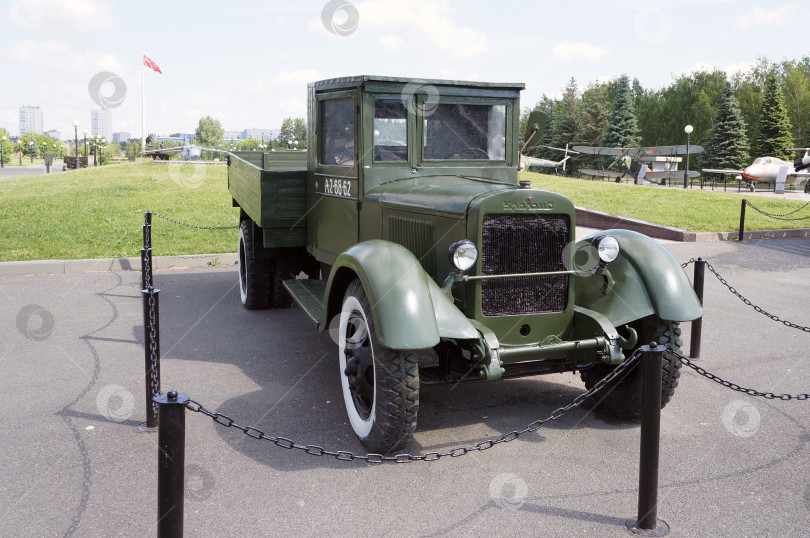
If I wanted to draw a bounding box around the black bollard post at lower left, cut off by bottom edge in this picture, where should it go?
[155,390,188,538]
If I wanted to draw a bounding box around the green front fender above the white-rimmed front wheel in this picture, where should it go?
[319,239,479,349]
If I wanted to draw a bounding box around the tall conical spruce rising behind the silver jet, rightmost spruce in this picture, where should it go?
[754,71,793,160]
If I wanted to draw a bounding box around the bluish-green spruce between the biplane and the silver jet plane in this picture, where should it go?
[701,83,749,170]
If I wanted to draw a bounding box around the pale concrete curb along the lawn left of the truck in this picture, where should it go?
[0,253,237,276]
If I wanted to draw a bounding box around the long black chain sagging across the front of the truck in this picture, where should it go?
[186,349,642,463]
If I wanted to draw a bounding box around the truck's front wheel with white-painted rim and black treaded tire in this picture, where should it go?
[338,279,419,454]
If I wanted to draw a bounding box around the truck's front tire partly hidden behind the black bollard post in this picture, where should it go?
[580,316,683,420]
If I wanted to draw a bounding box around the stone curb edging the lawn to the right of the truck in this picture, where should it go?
[576,207,810,243]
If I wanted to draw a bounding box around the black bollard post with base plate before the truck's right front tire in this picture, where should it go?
[625,342,669,536]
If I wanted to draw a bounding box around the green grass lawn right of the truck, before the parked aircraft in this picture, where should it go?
[520,172,810,232]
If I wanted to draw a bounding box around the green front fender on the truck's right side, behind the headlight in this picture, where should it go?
[575,230,703,326]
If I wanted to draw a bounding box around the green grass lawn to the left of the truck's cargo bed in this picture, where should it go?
[0,161,239,261]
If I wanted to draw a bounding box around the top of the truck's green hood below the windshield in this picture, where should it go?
[366,176,508,215]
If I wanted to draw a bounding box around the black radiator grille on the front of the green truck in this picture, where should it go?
[481,214,571,316]
